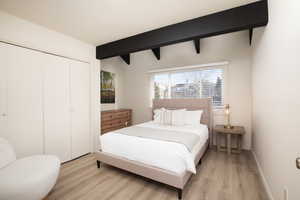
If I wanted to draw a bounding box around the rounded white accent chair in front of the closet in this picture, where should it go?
[0,138,60,200]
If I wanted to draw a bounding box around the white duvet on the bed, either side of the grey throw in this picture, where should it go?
[100,121,208,174]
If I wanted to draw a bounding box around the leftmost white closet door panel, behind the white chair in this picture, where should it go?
[0,42,43,157]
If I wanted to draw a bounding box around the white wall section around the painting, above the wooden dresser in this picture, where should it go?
[101,58,125,110]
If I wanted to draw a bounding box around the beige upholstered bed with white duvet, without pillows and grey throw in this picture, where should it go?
[96,99,212,199]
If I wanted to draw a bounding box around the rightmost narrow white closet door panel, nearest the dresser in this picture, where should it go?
[70,61,90,158]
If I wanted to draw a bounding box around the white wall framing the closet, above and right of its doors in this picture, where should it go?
[0,11,100,152]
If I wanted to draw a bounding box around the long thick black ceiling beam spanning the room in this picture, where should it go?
[96,0,268,59]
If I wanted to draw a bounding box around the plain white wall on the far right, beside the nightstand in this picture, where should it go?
[252,0,300,200]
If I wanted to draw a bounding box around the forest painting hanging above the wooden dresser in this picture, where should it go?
[100,70,116,104]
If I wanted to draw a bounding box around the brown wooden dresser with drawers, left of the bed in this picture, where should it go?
[101,109,132,134]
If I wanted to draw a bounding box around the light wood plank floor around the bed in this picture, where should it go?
[46,150,267,200]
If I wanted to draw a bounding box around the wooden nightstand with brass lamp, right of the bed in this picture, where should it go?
[214,125,245,154]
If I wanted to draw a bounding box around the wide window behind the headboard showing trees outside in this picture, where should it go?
[153,69,224,106]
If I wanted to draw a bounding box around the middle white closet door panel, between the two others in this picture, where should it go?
[44,55,71,162]
